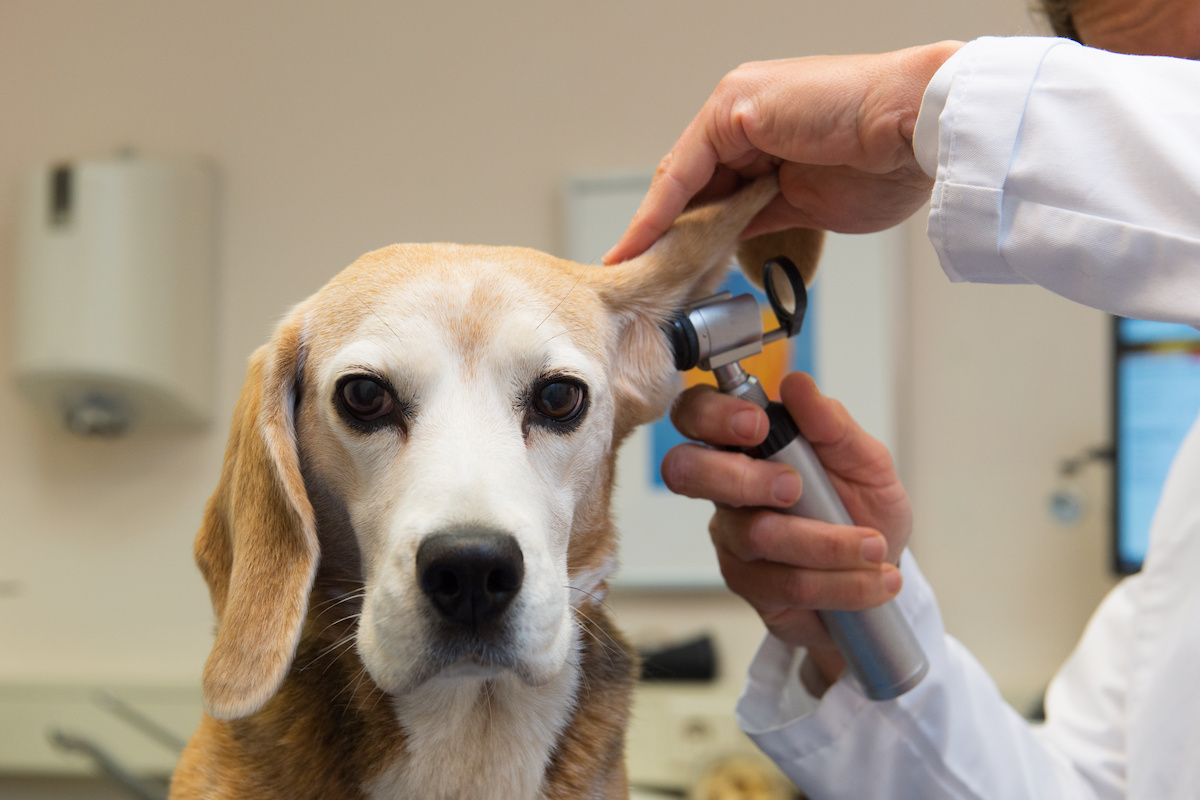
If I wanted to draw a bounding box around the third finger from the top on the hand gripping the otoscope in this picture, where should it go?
[709,507,888,570]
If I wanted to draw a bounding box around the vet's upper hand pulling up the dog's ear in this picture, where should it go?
[604,42,962,264]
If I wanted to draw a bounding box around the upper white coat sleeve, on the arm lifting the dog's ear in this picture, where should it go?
[913,37,1200,325]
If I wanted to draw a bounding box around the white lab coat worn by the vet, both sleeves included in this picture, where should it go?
[738,38,1200,800]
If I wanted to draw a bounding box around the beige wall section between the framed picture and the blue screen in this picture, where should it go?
[901,241,1112,695]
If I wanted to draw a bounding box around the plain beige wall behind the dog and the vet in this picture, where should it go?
[0,0,1105,700]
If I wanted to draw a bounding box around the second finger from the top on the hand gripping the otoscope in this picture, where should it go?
[662,444,802,507]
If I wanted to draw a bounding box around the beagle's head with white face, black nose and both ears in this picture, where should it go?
[196,181,820,718]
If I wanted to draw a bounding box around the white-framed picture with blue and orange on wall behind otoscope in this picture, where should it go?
[564,172,904,588]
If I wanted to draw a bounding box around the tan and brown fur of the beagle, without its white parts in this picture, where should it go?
[172,178,820,800]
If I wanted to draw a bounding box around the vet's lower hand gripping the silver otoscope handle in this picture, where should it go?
[662,373,912,682]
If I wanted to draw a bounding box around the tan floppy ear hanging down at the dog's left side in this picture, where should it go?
[196,317,318,720]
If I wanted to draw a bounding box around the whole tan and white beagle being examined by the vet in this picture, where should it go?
[170,179,820,800]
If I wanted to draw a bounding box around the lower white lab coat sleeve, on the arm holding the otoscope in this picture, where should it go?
[738,553,1124,800]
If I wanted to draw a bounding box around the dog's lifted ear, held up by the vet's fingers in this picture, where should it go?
[587,178,823,441]
